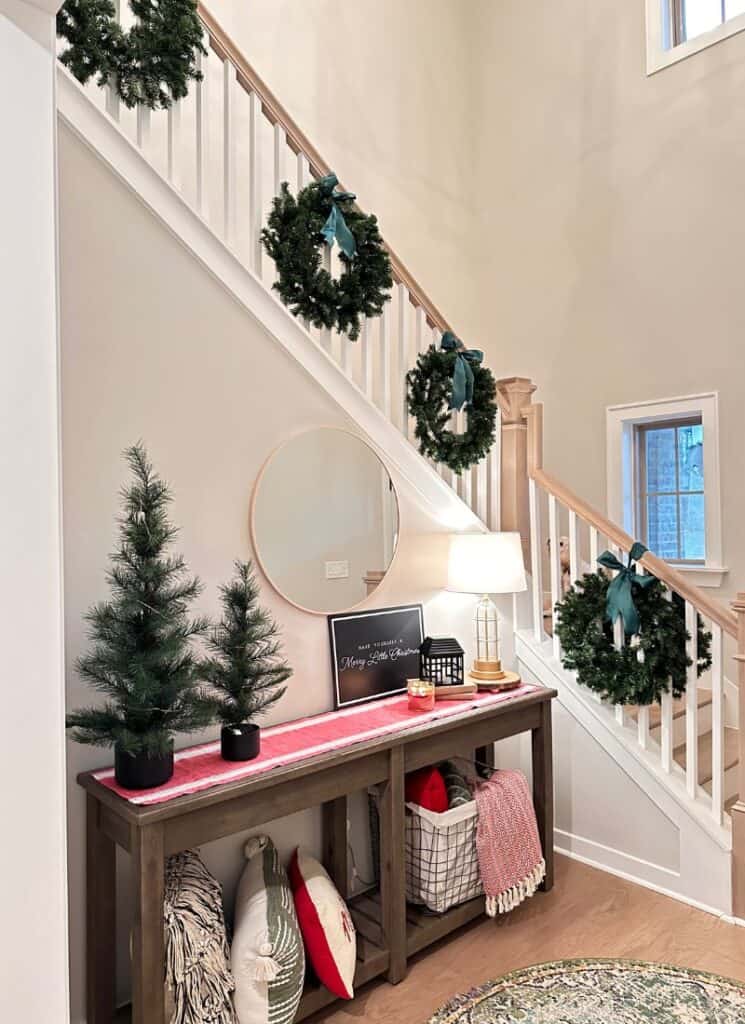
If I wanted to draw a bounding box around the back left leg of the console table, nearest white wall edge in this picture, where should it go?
[86,796,117,1024]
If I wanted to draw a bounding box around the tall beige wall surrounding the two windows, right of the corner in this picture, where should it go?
[471,0,745,593]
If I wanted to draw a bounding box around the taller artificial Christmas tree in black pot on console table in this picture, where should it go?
[67,444,215,788]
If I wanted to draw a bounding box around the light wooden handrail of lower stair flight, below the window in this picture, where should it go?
[525,402,737,638]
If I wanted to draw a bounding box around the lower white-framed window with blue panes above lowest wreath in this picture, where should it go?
[607,392,727,587]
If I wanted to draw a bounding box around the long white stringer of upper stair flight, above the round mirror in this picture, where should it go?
[57,67,486,530]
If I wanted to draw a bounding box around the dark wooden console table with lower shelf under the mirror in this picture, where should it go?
[78,688,556,1024]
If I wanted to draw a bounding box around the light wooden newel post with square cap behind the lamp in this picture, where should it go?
[496,377,536,563]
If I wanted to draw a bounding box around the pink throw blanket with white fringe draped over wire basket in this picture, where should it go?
[474,770,545,918]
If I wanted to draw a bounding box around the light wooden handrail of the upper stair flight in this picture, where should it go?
[198,3,450,331]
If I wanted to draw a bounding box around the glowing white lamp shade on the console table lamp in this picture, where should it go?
[447,534,528,594]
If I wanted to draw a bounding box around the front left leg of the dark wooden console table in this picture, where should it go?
[130,824,166,1024]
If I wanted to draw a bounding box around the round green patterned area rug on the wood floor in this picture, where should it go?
[429,959,745,1024]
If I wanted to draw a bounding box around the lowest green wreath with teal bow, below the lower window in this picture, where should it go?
[557,543,711,705]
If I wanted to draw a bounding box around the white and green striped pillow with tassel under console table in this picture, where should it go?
[230,836,305,1024]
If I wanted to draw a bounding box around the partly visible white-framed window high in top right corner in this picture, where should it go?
[647,0,745,75]
